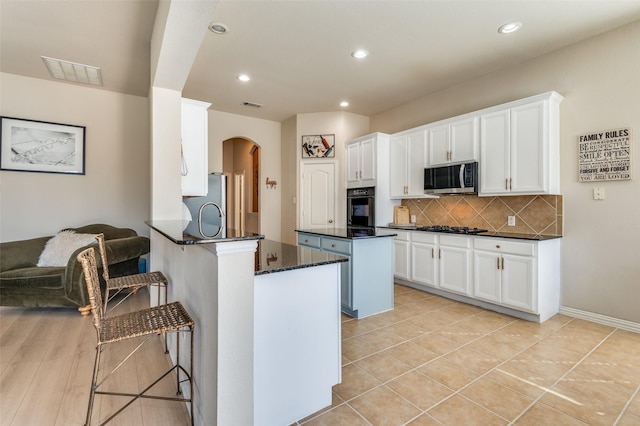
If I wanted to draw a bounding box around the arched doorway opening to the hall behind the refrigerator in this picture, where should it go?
[222,137,260,234]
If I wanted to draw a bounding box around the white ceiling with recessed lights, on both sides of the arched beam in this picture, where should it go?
[0,0,640,121]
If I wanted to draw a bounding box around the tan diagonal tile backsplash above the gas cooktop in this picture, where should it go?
[402,195,563,235]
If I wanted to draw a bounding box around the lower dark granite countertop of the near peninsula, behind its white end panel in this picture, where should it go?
[255,240,349,275]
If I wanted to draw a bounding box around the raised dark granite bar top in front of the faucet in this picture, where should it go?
[145,220,264,244]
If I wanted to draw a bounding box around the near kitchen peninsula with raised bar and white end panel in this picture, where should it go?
[147,220,346,425]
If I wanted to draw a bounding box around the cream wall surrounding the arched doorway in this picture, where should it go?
[209,110,282,241]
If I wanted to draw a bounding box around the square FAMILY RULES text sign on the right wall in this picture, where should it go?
[578,128,631,182]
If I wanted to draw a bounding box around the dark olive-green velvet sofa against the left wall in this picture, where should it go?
[0,224,150,315]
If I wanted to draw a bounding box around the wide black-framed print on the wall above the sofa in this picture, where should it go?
[0,117,86,175]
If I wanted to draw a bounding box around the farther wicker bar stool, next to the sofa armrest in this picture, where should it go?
[96,234,168,314]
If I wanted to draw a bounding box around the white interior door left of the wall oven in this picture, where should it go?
[300,163,336,229]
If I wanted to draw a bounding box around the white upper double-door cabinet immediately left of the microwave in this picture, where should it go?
[389,127,427,199]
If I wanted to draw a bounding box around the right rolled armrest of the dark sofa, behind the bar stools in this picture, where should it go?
[65,235,151,306]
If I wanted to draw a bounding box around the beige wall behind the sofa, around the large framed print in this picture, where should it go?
[0,73,150,241]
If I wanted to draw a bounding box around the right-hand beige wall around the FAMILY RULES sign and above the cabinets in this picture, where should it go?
[371,18,640,322]
